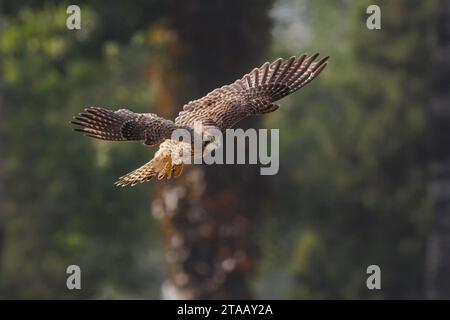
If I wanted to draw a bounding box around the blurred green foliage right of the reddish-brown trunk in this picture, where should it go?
[256,0,436,299]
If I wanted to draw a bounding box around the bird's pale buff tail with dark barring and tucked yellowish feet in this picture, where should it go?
[115,149,184,187]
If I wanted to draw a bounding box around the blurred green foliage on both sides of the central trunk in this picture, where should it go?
[0,0,436,299]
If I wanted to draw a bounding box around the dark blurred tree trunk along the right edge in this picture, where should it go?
[426,0,450,299]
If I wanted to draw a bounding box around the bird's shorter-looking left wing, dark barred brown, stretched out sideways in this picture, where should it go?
[72,107,177,145]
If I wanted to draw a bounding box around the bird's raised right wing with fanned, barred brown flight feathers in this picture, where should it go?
[175,53,328,130]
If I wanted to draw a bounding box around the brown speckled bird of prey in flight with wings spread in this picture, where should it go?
[72,53,329,186]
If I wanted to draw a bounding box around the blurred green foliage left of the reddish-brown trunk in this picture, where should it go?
[0,2,162,298]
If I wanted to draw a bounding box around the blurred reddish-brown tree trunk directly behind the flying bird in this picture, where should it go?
[149,0,271,299]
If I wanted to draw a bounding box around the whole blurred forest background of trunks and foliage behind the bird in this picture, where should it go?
[0,0,450,299]
